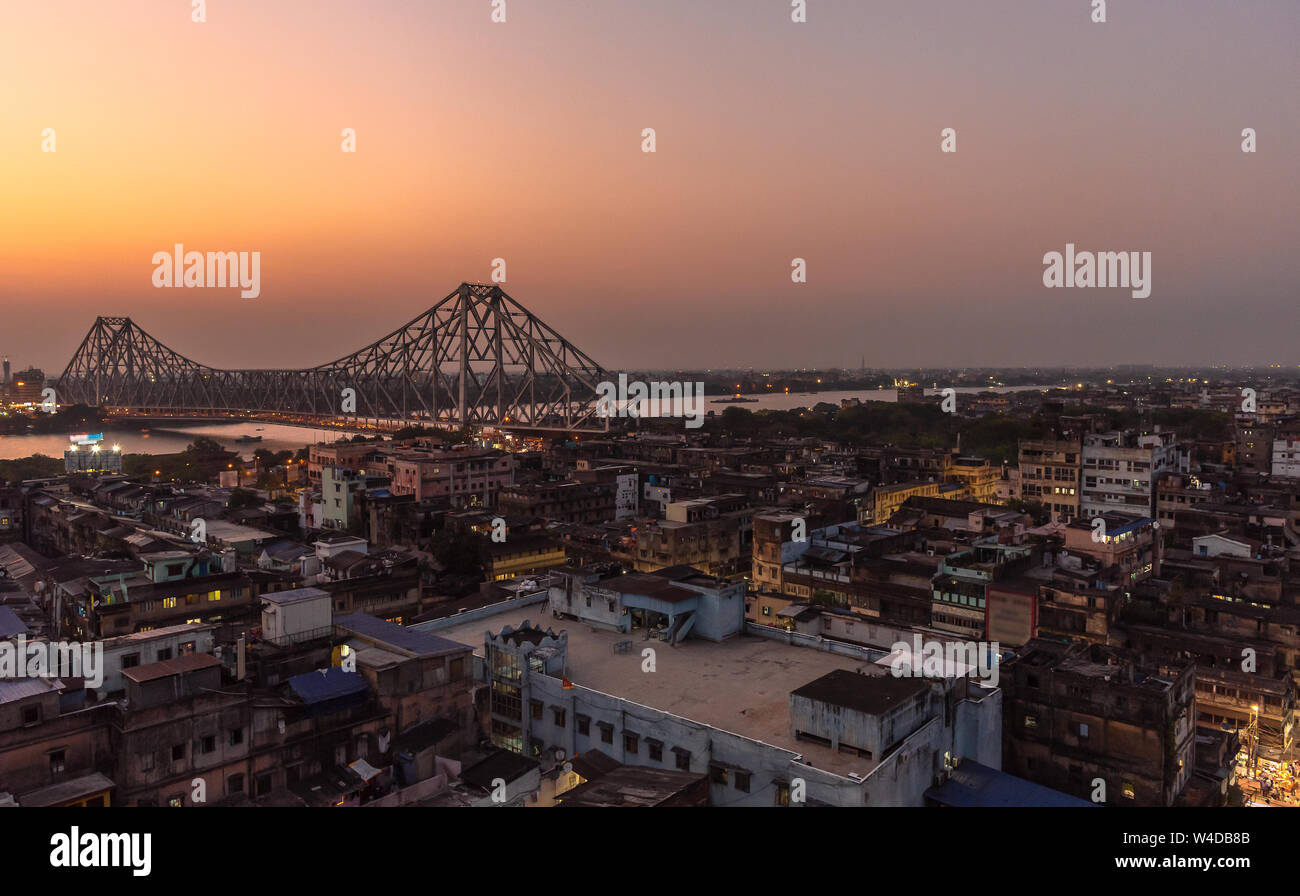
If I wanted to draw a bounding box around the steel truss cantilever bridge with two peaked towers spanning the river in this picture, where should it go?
[56,283,611,432]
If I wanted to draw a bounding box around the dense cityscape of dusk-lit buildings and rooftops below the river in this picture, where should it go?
[0,351,1300,806]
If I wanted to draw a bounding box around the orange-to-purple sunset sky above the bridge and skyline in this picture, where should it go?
[0,0,1300,376]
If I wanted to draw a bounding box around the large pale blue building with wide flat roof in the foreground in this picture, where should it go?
[438,613,1001,806]
